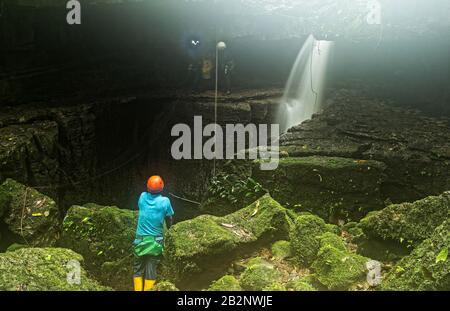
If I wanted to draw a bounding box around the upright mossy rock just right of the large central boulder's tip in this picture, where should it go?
[290,215,327,267]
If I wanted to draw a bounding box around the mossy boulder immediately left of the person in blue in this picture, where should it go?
[60,204,137,290]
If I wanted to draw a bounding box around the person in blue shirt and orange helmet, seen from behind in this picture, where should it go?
[134,176,174,291]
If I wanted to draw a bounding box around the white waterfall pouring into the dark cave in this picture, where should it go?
[278,35,334,132]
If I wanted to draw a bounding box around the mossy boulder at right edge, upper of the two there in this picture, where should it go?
[359,191,450,246]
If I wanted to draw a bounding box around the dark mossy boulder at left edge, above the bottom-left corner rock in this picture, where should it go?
[0,179,60,246]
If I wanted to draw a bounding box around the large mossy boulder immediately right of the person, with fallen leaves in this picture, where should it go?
[163,195,291,288]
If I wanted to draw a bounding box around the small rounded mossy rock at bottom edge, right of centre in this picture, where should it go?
[240,265,281,291]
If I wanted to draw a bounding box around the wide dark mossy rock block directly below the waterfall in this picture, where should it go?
[253,156,386,221]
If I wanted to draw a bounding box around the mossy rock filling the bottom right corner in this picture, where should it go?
[381,220,450,291]
